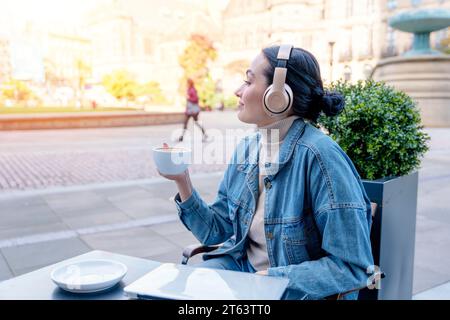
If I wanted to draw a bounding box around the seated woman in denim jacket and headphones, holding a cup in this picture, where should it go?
[158,45,373,299]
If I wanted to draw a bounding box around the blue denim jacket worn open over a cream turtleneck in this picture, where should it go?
[175,119,373,299]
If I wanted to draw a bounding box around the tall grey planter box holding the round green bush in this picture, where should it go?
[359,172,419,300]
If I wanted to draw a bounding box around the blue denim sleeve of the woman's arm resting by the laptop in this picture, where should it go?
[268,145,373,299]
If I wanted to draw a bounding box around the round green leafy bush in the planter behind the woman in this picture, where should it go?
[318,80,430,180]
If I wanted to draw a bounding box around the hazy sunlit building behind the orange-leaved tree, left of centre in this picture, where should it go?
[85,0,221,103]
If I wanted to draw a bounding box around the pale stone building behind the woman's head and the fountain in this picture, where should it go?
[220,0,450,91]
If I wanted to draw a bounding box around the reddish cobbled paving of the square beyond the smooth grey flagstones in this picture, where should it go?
[0,111,249,193]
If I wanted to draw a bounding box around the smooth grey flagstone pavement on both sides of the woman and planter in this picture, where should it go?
[0,129,450,299]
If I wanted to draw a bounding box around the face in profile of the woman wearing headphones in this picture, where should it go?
[234,53,275,127]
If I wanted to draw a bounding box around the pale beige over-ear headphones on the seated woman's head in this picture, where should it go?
[263,44,294,117]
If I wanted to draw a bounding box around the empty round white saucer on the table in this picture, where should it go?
[51,259,127,293]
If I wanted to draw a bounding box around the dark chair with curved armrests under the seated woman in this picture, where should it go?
[181,202,386,300]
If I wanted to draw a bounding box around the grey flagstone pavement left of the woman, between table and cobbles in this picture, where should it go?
[0,173,222,281]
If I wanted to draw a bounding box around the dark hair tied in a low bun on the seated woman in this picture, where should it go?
[262,46,345,122]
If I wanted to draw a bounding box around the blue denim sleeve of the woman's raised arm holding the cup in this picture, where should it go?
[175,169,233,245]
